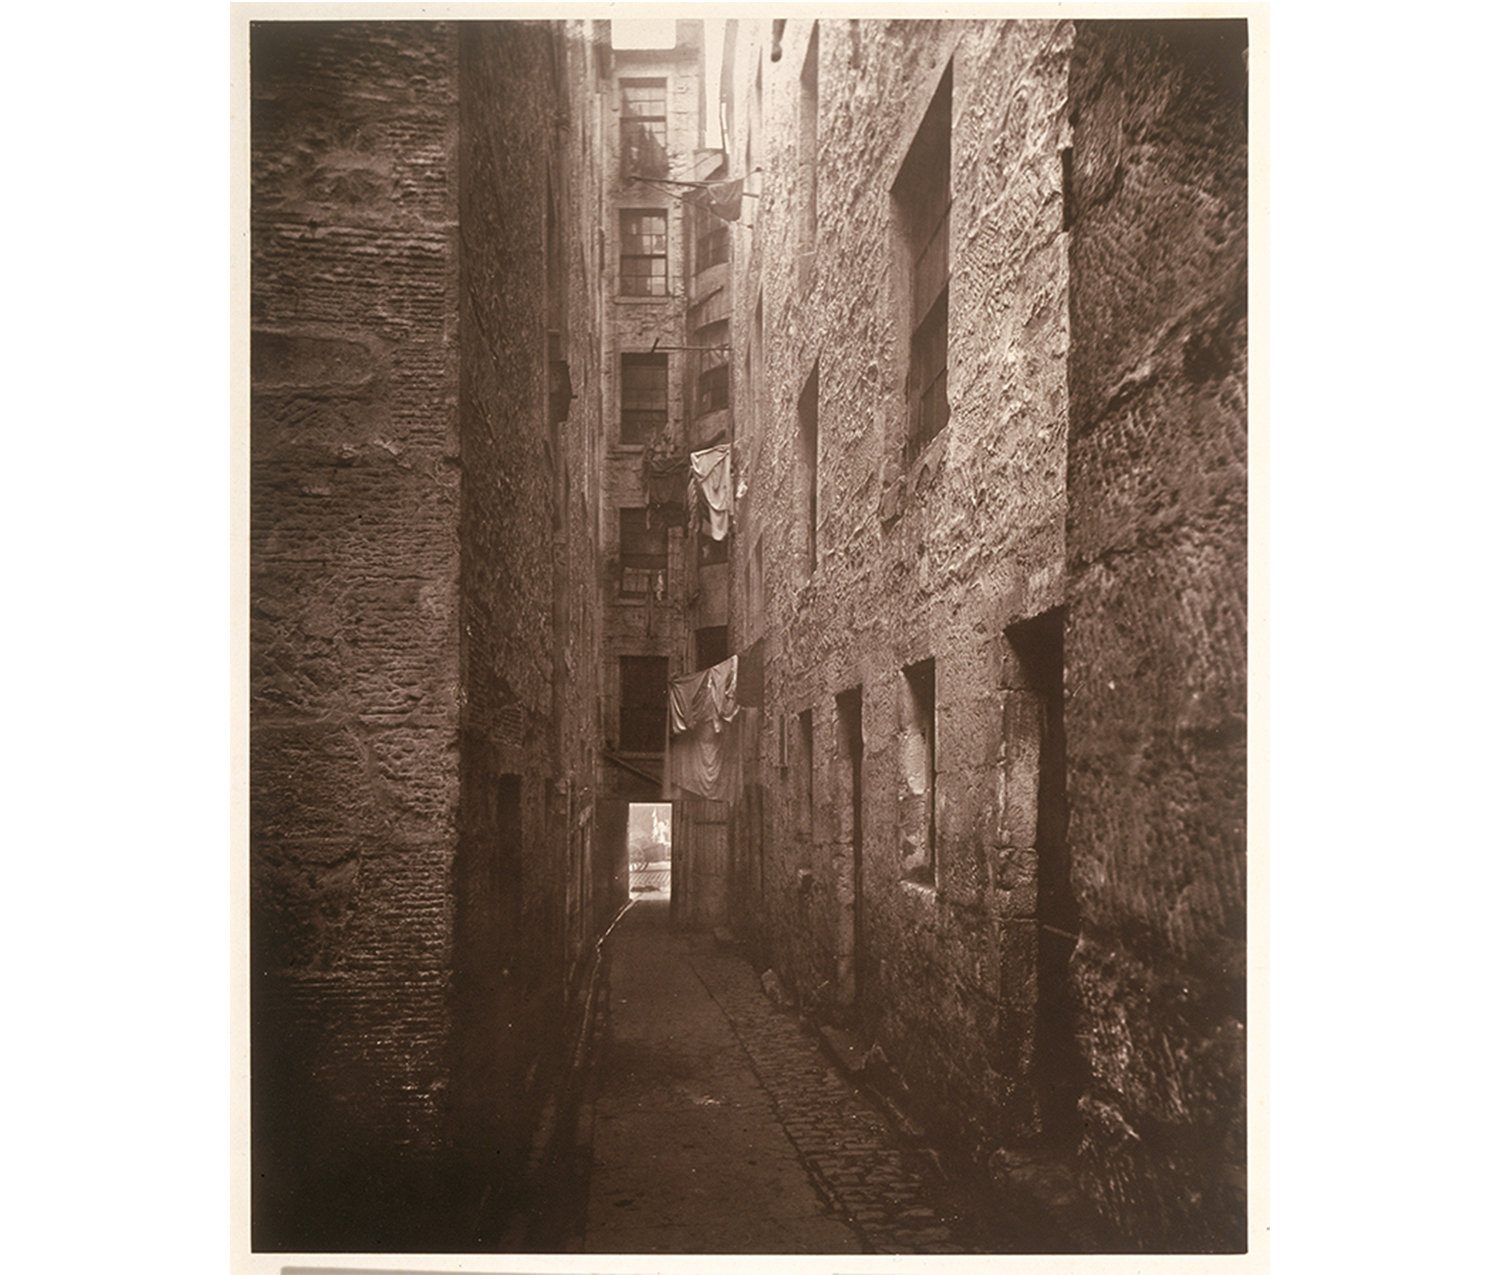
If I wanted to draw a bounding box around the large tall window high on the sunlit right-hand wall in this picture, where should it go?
[891,65,953,462]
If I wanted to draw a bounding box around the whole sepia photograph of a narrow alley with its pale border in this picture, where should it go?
[233,5,1269,1271]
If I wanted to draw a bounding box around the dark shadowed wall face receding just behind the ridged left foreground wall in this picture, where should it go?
[452,23,570,1188]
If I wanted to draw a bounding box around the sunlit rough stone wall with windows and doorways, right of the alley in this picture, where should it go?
[731,20,1071,1155]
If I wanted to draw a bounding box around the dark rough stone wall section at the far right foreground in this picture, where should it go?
[1067,21,1248,1251]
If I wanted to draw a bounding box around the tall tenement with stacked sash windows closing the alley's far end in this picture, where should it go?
[599,20,729,924]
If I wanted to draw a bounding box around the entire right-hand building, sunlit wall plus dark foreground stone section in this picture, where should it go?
[723,20,1248,1251]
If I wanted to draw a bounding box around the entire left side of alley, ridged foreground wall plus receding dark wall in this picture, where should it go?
[251,23,609,1251]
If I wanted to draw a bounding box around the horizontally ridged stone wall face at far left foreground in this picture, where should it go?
[251,24,459,1245]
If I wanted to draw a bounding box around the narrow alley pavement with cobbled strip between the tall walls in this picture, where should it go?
[584,905,1043,1254]
